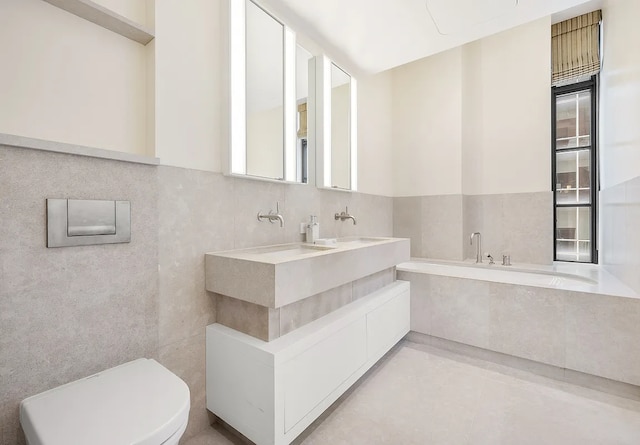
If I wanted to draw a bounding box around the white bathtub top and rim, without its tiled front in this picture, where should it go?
[397,258,640,298]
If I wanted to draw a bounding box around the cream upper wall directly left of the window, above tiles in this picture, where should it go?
[462,17,551,195]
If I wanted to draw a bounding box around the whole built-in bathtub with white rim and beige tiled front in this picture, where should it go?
[397,259,640,385]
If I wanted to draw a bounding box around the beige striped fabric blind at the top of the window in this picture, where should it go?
[551,10,602,86]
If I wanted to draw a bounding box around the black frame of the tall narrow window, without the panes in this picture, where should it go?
[551,74,600,264]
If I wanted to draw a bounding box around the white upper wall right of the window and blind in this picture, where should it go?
[599,0,640,188]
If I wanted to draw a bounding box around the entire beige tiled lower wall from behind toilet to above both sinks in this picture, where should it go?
[0,147,393,445]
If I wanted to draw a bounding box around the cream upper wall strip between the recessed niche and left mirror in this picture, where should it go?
[155,0,222,172]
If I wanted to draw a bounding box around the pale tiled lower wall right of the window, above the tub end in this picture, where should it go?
[600,177,640,292]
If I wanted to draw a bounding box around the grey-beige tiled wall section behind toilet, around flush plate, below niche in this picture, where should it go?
[0,147,159,445]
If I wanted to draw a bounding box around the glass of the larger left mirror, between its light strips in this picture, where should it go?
[245,0,284,179]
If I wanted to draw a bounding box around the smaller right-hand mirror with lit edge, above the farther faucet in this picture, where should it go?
[317,57,358,190]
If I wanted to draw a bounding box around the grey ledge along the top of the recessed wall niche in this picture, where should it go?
[44,0,154,45]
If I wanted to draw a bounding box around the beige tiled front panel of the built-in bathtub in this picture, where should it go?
[398,270,640,385]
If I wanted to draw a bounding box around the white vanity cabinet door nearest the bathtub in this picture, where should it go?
[367,291,410,360]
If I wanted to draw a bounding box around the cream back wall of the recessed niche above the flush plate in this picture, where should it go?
[0,0,147,154]
